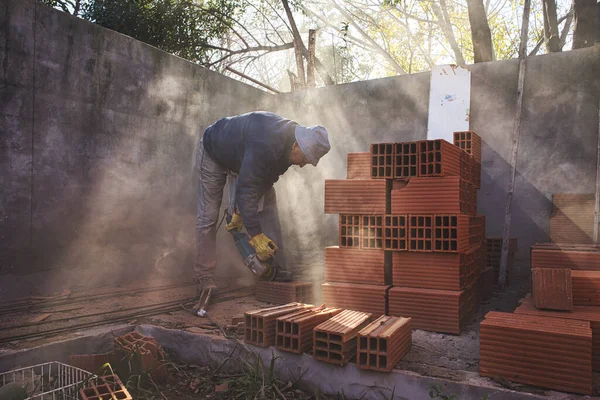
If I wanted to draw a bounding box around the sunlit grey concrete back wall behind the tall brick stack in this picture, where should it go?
[273,46,600,261]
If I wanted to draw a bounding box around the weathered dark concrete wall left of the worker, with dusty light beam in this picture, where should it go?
[0,0,269,288]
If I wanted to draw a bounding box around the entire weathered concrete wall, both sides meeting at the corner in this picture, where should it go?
[0,0,600,290]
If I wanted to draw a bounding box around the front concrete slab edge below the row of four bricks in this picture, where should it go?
[136,325,548,400]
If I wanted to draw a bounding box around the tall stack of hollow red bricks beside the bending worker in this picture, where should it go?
[323,132,485,334]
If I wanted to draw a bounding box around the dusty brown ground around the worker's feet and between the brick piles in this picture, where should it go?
[0,264,598,399]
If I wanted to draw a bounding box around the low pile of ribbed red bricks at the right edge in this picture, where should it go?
[480,243,600,394]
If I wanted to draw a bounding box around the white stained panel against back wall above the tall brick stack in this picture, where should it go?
[427,65,471,143]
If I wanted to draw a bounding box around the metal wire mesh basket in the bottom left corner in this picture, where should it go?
[0,361,92,400]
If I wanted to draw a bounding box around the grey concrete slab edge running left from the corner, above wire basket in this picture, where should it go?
[0,324,134,372]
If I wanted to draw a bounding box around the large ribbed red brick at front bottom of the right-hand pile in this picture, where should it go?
[479,311,592,394]
